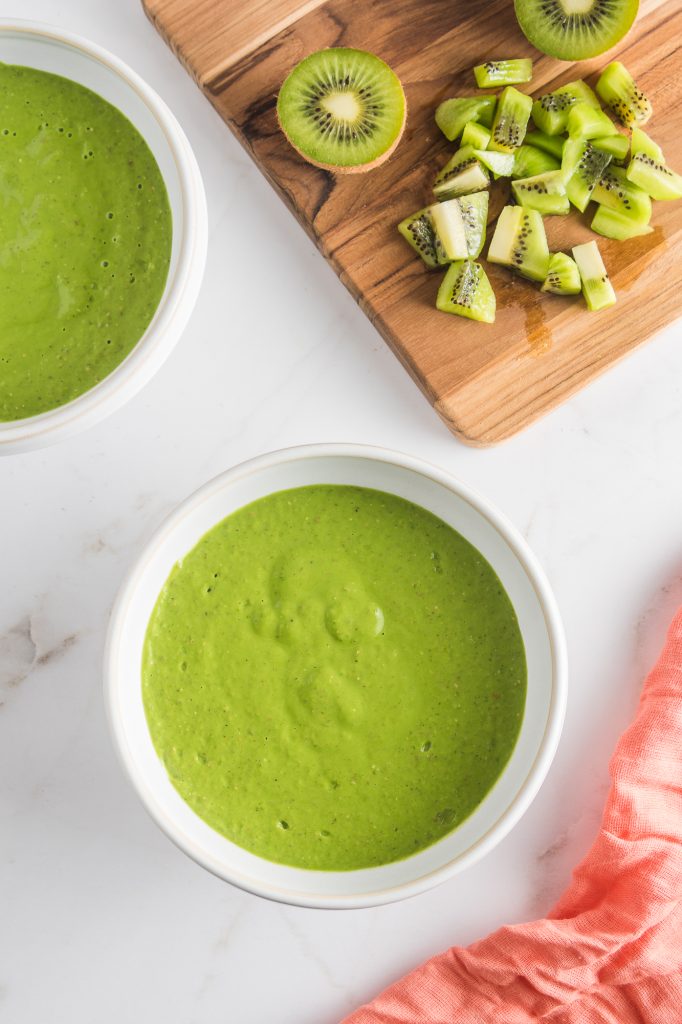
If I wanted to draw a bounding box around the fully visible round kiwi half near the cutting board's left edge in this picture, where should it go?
[278,48,407,174]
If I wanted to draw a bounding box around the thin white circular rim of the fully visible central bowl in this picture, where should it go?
[103,442,567,909]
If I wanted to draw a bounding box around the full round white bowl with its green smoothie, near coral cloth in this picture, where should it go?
[104,444,566,907]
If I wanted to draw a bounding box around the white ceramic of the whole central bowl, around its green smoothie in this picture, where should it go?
[104,444,566,907]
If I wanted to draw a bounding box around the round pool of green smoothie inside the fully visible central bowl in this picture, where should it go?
[142,484,526,870]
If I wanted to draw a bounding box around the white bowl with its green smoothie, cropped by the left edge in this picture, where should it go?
[0,20,207,454]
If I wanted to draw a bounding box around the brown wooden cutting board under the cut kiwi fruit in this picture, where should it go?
[143,0,682,444]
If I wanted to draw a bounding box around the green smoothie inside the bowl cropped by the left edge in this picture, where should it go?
[0,63,172,421]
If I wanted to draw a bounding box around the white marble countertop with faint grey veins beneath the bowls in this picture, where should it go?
[0,0,682,1024]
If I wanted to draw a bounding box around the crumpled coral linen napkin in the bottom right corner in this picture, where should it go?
[344,608,682,1024]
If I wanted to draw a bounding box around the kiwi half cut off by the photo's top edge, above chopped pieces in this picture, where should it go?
[514,0,639,60]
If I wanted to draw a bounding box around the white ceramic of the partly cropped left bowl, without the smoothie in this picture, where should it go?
[0,19,208,455]
